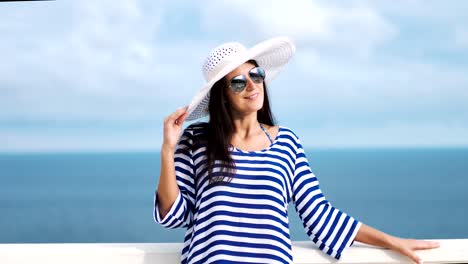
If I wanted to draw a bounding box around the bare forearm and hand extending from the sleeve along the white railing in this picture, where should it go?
[355,224,439,263]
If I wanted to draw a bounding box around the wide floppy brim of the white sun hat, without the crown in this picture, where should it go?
[186,37,296,121]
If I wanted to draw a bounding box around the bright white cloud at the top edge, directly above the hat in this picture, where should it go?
[201,0,398,55]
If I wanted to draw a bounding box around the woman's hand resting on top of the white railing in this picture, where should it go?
[391,237,440,263]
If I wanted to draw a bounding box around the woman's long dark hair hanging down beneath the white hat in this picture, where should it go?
[196,60,276,187]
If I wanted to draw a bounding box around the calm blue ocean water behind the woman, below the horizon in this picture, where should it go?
[0,148,468,243]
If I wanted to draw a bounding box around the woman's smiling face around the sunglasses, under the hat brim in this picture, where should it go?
[225,62,264,115]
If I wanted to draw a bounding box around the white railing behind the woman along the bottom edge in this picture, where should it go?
[0,239,468,264]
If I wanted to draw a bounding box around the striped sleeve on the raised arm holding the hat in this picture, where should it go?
[153,127,195,228]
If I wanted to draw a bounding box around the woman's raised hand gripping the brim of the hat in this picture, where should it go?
[162,106,188,151]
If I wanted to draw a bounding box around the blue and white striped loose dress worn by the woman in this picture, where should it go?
[154,122,361,264]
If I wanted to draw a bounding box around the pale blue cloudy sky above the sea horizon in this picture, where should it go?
[0,0,468,152]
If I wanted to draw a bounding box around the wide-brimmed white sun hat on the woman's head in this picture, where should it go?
[186,37,296,120]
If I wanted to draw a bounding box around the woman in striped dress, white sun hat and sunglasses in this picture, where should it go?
[154,37,438,263]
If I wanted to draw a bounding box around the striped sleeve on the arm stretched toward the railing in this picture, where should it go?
[293,135,361,259]
